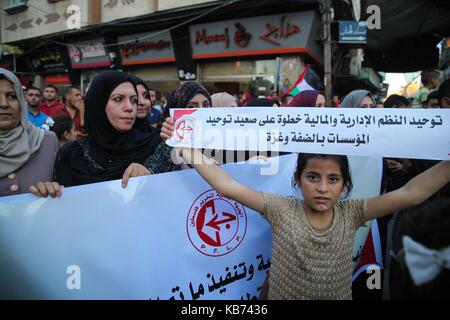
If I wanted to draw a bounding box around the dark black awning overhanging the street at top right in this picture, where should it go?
[335,0,450,72]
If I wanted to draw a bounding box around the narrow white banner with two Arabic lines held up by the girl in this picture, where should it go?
[167,107,450,160]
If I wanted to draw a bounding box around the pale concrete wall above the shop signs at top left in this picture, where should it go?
[0,0,221,43]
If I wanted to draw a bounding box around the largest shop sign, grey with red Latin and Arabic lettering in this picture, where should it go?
[190,11,320,59]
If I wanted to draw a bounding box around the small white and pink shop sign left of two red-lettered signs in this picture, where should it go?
[67,39,111,69]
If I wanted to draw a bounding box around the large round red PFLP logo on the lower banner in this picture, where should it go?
[186,190,247,257]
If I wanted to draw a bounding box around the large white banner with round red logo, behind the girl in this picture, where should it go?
[0,155,379,300]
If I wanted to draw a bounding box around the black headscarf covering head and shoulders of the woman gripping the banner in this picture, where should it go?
[55,71,160,185]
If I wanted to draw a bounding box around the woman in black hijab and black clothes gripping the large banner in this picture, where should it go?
[54,71,177,187]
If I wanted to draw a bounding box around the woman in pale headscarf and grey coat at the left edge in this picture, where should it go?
[0,68,60,197]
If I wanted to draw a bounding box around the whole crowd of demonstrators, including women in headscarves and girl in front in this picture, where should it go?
[0,68,450,299]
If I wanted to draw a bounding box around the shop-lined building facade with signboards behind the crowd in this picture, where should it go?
[0,0,390,96]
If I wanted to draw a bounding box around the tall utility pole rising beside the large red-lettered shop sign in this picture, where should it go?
[320,0,333,103]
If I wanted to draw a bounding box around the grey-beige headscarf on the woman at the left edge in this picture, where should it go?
[0,68,45,178]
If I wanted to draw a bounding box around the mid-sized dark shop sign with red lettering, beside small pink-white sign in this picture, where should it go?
[117,31,175,65]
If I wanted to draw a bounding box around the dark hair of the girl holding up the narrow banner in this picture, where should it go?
[293,153,353,199]
